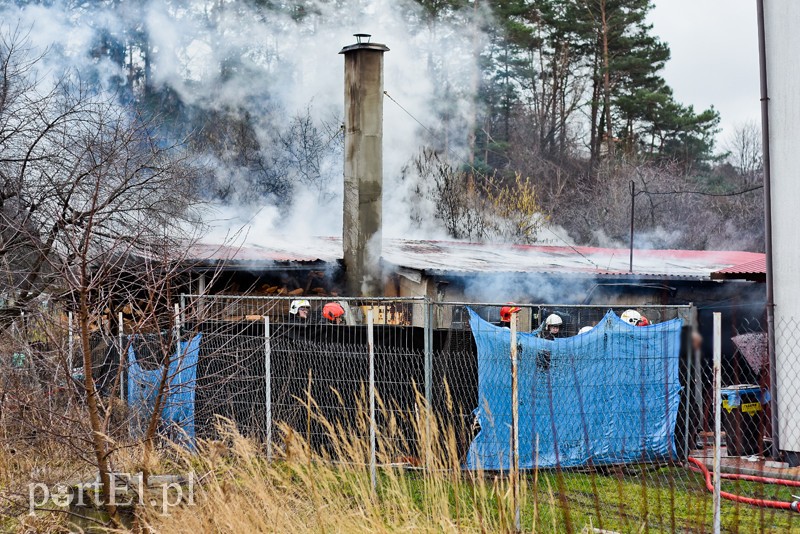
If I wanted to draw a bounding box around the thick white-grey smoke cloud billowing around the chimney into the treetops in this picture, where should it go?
[0,0,489,243]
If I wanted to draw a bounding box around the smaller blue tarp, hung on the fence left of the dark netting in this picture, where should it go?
[128,334,201,448]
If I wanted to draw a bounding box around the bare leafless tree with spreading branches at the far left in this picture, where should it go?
[0,25,212,524]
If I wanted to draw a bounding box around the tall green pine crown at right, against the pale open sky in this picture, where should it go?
[566,0,719,170]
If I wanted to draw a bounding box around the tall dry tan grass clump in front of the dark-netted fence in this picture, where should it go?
[145,394,540,533]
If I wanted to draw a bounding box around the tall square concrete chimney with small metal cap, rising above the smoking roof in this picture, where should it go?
[339,34,389,297]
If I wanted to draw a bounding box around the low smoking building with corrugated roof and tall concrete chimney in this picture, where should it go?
[177,34,766,362]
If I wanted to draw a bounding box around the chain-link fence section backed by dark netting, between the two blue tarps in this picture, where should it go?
[182,296,427,456]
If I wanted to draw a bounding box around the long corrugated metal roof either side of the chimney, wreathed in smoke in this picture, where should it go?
[191,236,764,280]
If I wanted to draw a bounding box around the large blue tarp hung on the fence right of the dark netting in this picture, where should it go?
[466,310,682,470]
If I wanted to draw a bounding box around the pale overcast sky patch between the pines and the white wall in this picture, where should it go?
[650,0,760,148]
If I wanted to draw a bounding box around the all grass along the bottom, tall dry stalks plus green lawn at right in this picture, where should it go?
[6,392,795,534]
